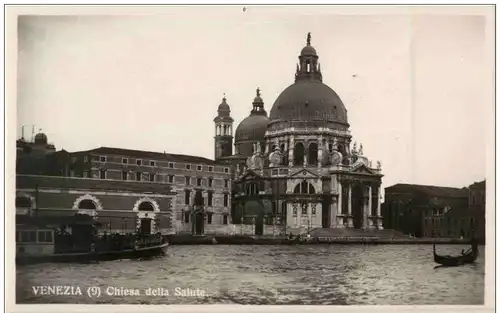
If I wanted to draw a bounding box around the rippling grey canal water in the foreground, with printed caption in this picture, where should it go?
[16,245,484,305]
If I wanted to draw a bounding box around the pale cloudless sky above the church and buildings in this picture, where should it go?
[17,6,494,187]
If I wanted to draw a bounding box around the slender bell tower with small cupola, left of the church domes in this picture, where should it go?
[214,94,234,161]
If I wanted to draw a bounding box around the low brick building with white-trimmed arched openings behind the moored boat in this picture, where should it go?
[15,175,176,235]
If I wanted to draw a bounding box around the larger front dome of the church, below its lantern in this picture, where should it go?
[269,80,348,126]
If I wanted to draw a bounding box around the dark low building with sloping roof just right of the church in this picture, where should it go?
[382,184,469,237]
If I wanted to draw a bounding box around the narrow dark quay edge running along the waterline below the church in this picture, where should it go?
[166,234,483,245]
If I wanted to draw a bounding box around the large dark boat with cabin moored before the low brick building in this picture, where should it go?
[16,216,169,265]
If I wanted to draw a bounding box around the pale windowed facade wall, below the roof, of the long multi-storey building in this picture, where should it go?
[72,153,232,232]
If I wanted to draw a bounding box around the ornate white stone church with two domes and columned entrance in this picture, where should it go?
[214,33,383,235]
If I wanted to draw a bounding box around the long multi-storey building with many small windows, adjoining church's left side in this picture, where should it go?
[16,135,232,234]
